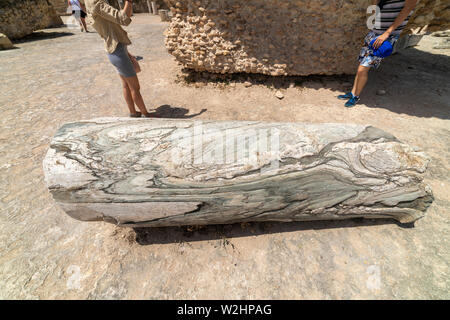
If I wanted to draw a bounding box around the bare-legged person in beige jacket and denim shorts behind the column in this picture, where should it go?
[85,0,150,117]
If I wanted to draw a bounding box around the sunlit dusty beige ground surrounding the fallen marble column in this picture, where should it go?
[0,14,450,299]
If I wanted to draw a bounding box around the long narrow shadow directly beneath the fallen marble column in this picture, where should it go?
[133,218,414,245]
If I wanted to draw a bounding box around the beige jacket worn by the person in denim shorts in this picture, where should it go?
[85,0,131,53]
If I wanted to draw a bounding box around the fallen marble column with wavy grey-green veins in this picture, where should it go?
[44,118,433,227]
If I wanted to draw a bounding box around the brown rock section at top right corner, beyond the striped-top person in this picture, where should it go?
[408,0,450,31]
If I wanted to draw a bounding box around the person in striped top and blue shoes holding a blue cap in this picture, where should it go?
[338,0,417,108]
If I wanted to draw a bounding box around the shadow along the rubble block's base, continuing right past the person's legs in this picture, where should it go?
[178,48,450,119]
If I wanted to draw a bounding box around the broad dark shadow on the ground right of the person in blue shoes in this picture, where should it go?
[361,48,450,120]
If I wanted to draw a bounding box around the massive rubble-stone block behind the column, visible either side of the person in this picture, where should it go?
[166,0,450,76]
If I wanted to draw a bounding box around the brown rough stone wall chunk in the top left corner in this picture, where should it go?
[0,0,63,39]
